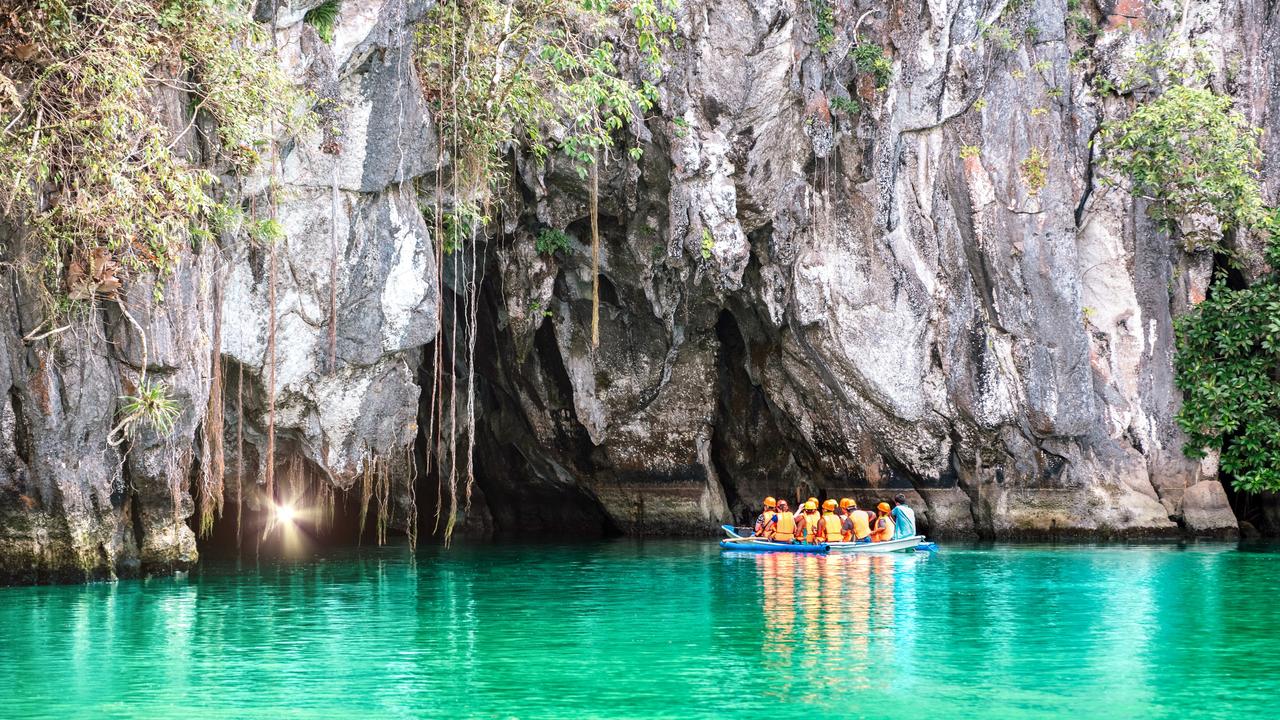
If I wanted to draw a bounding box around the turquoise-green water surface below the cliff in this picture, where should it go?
[0,541,1280,720]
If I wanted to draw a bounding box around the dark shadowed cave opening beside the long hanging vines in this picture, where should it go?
[415,245,621,542]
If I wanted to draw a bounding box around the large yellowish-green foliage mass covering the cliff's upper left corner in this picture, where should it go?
[0,0,300,307]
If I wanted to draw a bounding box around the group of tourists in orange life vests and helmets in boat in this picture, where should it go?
[754,493,915,544]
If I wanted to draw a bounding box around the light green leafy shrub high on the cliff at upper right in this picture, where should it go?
[1101,86,1267,243]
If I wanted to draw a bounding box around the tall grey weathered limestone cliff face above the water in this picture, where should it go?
[0,0,1280,579]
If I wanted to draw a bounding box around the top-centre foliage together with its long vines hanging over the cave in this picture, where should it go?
[417,0,676,542]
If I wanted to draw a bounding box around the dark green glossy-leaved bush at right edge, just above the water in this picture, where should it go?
[1174,265,1280,492]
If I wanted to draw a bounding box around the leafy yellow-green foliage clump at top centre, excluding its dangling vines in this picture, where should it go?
[417,0,675,196]
